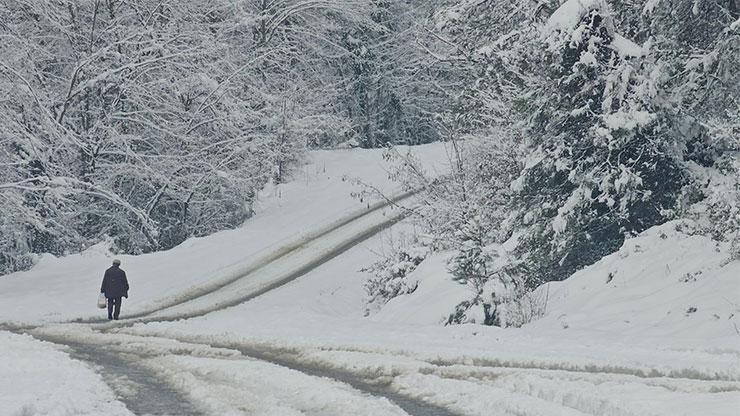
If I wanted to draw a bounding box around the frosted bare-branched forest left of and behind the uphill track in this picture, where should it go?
[0,0,444,274]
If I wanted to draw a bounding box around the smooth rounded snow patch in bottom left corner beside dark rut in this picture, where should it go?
[0,331,132,416]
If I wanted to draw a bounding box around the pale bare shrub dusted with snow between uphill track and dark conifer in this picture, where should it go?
[386,134,520,250]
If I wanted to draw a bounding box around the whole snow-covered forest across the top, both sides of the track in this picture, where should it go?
[0,0,740,312]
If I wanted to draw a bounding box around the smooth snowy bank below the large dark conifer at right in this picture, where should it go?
[527,221,740,349]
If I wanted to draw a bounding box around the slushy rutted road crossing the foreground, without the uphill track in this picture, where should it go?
[14,324,740,416]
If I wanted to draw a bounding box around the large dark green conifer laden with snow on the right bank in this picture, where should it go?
[508,1,687,284]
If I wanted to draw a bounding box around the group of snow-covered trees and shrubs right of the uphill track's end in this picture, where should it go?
[378,0,740,319]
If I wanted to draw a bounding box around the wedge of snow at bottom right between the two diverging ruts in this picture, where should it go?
[394,371,740,416]
